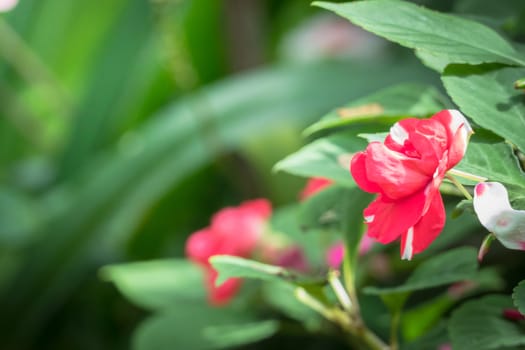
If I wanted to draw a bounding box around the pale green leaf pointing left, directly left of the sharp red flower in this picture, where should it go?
[274,133,367,187]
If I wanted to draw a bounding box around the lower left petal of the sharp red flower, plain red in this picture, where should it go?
[364,191,426,244]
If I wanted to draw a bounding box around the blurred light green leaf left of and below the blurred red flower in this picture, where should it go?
[100,259,206,310]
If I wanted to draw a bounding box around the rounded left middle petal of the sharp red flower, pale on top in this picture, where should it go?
[366,142,430,200]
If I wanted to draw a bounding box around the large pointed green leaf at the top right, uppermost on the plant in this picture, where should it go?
[314,0,525,65]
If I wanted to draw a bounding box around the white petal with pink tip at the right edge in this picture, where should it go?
[473,182,525,250]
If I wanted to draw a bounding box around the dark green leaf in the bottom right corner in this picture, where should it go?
[448,295,525,350]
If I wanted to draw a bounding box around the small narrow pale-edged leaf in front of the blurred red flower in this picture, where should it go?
[210,255,308,285]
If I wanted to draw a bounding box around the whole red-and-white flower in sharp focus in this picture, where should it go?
[350,110,472,260]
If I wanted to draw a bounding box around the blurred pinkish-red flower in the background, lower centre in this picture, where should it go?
[186,199,272,305]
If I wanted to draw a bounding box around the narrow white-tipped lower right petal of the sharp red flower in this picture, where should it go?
[401,193,446,260]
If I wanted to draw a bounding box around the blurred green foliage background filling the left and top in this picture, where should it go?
[0,0,504,349]
